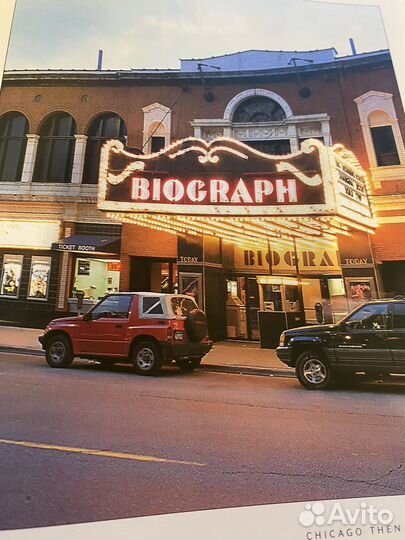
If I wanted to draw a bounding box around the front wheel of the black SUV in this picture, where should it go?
[295,351,332,390]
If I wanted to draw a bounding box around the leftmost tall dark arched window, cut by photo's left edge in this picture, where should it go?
[0,112,28,182]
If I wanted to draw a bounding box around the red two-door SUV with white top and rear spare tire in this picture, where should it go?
[39,292,212,375]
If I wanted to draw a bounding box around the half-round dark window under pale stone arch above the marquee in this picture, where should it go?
[232,96,286,123]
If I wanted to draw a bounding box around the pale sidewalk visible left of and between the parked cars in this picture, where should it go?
[0,326,294,377]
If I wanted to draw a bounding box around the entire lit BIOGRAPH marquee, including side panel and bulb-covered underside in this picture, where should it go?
[98,137,375,242]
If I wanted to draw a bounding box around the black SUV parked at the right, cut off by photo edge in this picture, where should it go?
[277,298,405,390]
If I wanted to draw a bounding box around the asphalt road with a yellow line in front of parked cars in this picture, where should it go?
[0,353,405,529]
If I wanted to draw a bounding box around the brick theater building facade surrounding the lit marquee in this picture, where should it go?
[0,49,405,338]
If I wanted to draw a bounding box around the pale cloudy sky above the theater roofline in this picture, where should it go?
[6,0,387,69]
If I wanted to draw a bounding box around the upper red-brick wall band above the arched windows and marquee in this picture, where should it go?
[0,62,405,161]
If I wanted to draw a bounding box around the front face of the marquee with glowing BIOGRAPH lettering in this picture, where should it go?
[98,137,334,216]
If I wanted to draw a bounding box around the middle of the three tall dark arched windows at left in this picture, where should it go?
[33,112,76,183]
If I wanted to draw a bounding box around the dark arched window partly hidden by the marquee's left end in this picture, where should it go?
[83,113,127,184]
